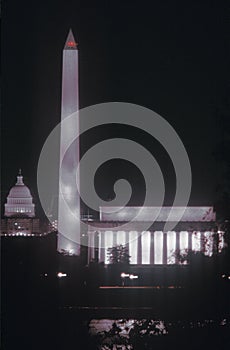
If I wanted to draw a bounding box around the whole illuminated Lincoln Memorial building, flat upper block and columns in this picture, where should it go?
[88,207,224,265]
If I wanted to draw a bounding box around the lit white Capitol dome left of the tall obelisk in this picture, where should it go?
[5,171,35,217]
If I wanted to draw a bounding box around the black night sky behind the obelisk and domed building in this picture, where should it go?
[2,0,229,217]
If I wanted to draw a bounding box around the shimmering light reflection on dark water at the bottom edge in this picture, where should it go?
[88,319,229,350]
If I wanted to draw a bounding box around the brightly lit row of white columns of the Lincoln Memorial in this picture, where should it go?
[88,230,223,265]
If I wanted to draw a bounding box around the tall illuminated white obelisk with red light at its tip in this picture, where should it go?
[58,29,81,255]
